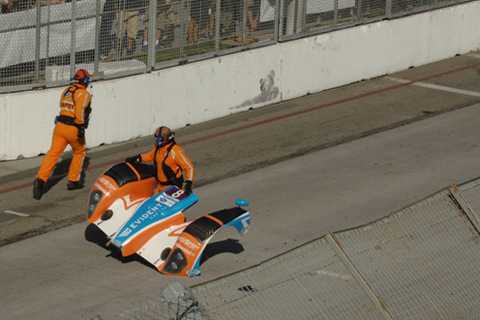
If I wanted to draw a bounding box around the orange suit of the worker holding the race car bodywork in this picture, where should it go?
[141,141,195,194]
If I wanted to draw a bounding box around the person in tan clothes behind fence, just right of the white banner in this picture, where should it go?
[115,0,145,56]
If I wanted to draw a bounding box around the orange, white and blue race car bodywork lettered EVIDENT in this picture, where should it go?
[86,163,250,276]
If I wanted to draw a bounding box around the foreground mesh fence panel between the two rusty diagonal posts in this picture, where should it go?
[336,191,480,319]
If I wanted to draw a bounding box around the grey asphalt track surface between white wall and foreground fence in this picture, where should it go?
[0,53,480,319]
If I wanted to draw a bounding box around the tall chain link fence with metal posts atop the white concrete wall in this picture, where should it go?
[0,0,470,93]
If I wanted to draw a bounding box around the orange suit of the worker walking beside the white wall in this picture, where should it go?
[37,83,91,182]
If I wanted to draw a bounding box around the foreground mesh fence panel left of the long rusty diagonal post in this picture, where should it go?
[191,238,382,319]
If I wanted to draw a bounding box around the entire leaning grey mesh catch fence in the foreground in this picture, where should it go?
[94,178,480,320]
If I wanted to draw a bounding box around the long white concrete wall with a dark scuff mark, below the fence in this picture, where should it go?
[0,1,480,160]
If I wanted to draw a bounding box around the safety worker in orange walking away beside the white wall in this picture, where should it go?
[33,69,92,200]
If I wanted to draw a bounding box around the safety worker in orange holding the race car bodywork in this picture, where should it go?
[125,126,195,195]
